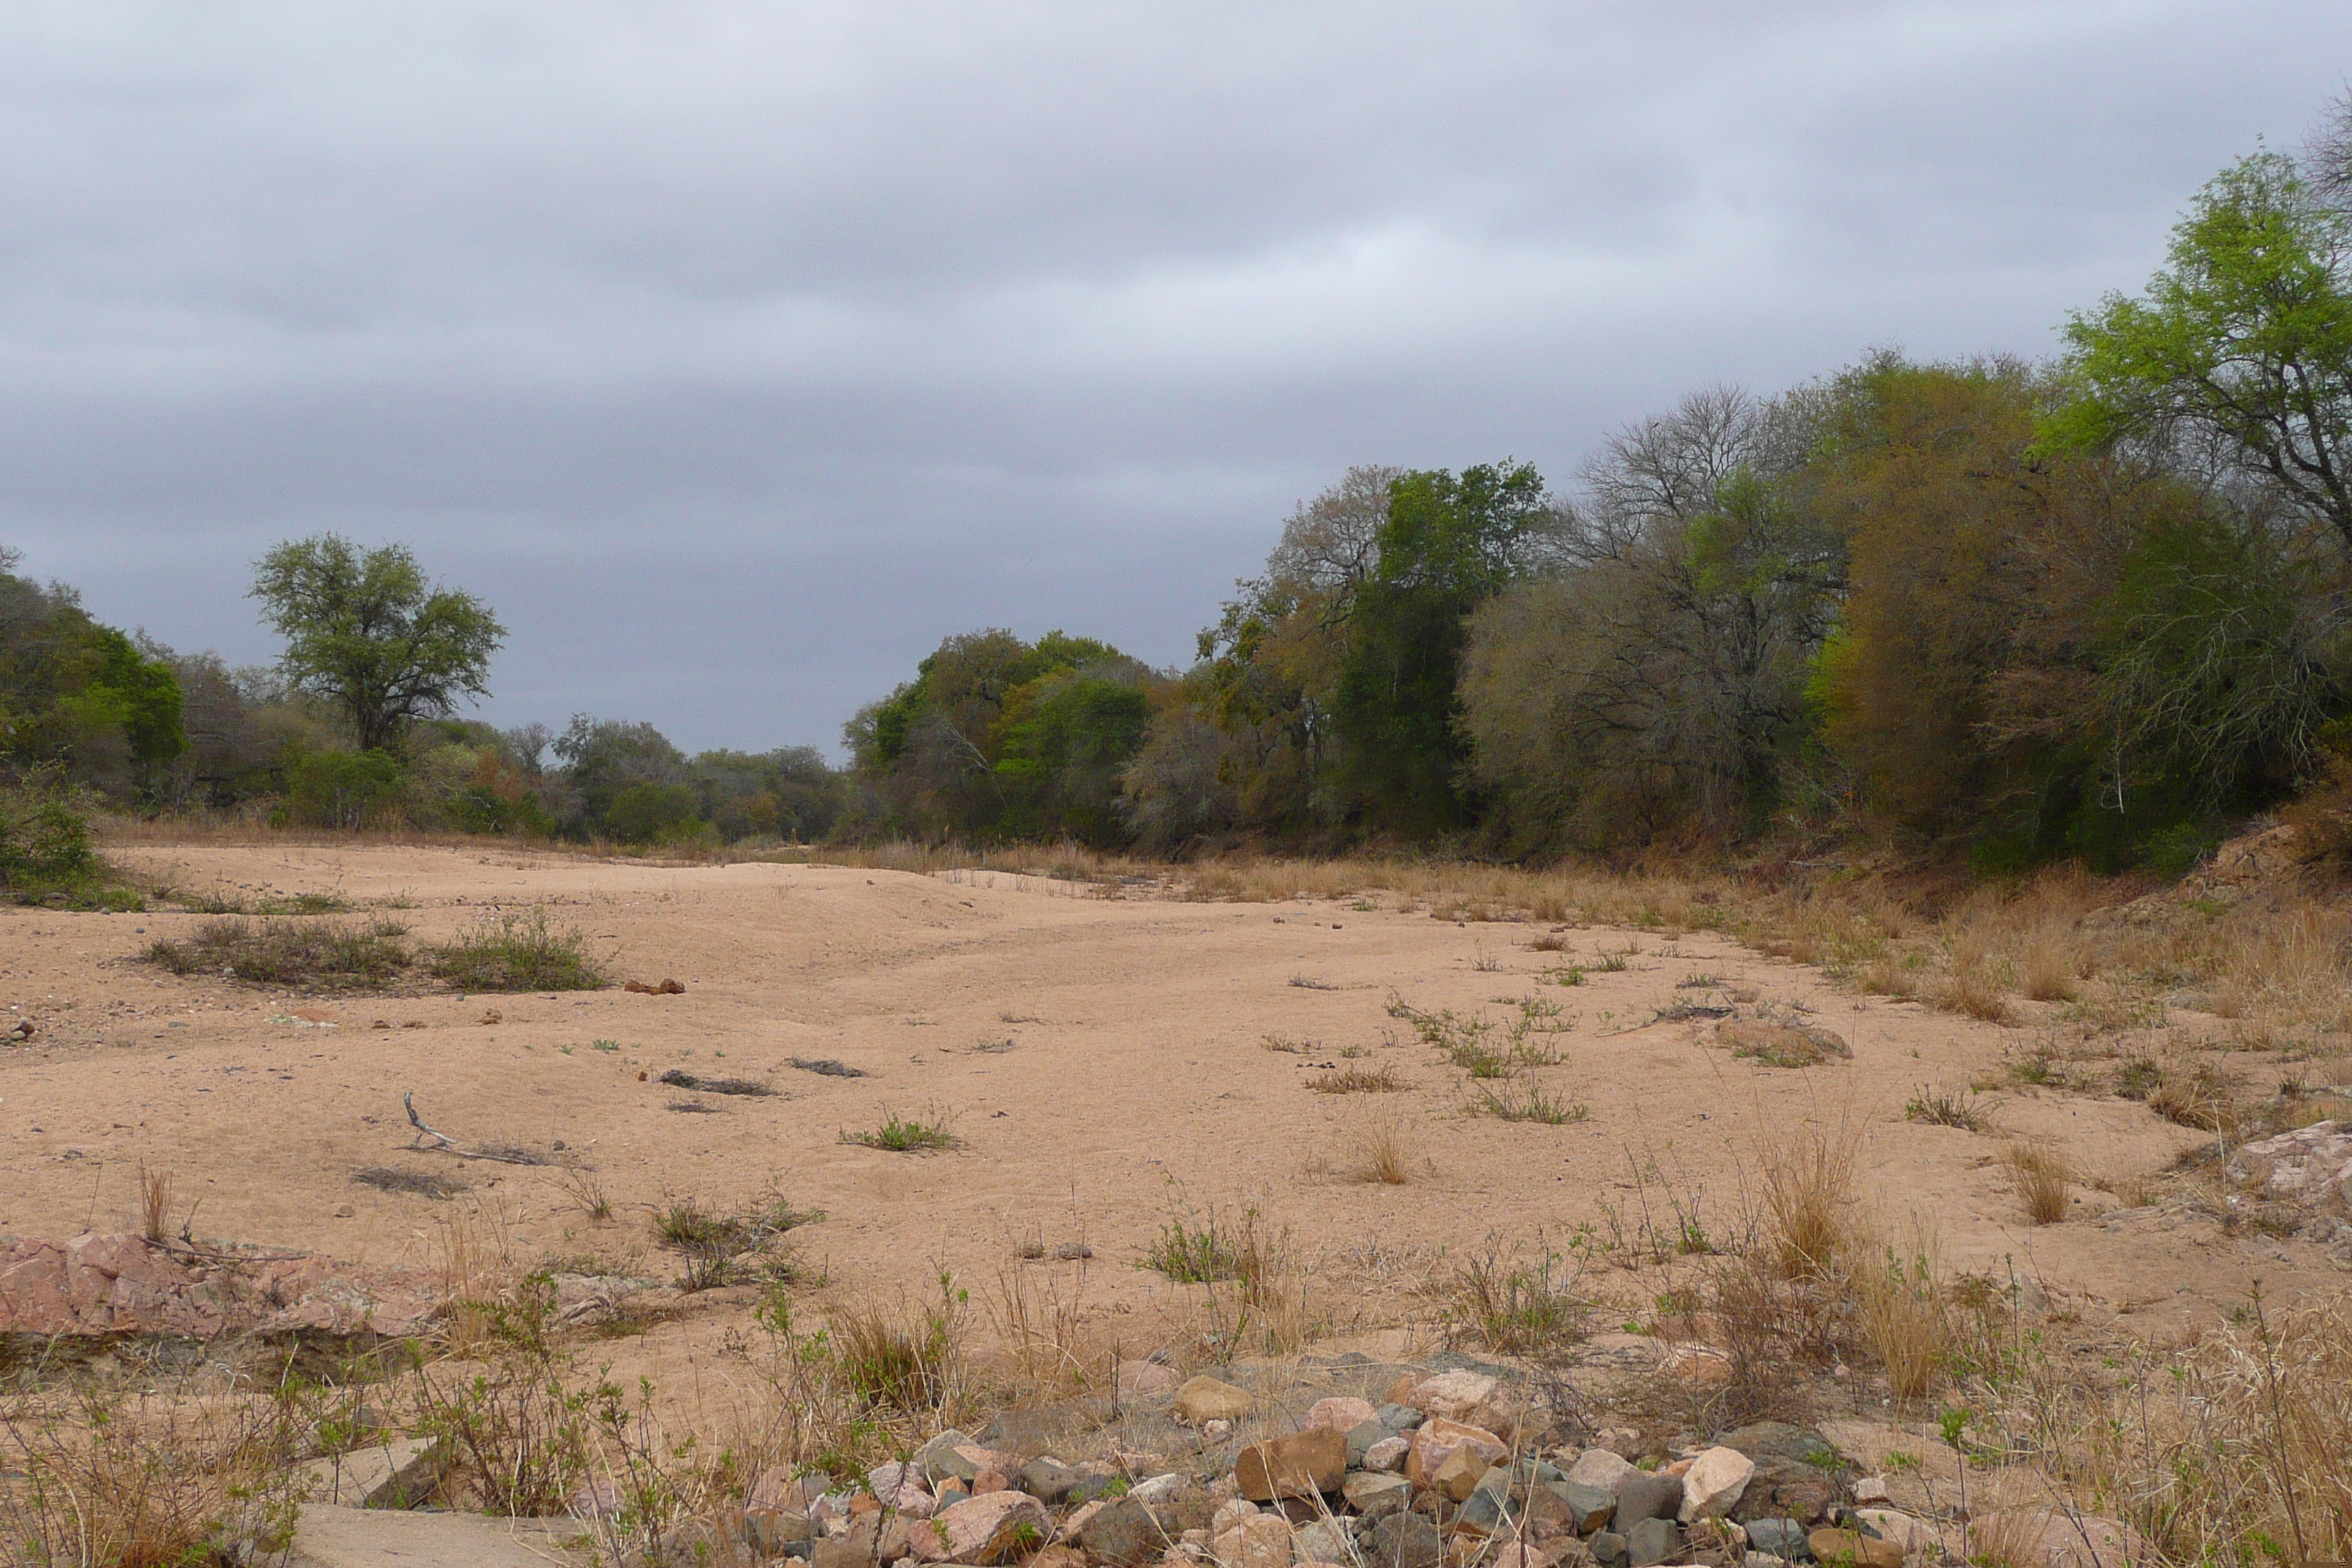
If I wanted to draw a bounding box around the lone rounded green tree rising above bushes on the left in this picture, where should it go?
[252,534,505,753]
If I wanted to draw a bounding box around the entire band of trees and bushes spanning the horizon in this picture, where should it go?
[0,127,2352,870]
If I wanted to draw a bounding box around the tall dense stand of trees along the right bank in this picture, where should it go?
[847,139,2352,870]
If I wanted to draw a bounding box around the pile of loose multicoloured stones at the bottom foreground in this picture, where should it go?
[743,1368,1934,1568]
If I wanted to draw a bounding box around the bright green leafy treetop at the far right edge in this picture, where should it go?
[2044,153,2352,548]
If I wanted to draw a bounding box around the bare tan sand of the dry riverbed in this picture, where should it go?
[0,846,2342,1363]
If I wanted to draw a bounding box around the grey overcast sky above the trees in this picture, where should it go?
[0,0,2352,750]
